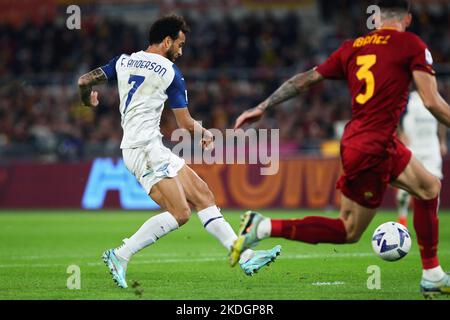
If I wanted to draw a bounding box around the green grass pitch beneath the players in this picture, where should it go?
[0,210,450,300]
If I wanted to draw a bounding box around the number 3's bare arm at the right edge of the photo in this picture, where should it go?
[413,71,450,127]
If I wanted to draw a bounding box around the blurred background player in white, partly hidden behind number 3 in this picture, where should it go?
[397,91,447,227]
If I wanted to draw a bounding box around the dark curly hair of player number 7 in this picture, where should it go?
[148,14,191,44]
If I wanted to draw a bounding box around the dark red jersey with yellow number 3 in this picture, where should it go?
[316,29,434,154]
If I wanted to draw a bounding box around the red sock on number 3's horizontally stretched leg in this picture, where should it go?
[271,217,347,244]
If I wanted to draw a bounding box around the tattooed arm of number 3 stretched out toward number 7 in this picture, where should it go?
[234,68,324,129]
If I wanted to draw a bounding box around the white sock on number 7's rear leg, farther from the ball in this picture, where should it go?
[115,211,179,261]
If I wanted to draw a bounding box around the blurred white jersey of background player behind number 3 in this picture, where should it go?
[402,91,442,178]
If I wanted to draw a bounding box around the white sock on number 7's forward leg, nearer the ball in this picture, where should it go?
[197,206,254,262]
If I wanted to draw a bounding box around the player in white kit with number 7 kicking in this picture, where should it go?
[78,15,281,288]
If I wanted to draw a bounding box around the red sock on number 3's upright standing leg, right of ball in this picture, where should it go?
[414,197,439,269]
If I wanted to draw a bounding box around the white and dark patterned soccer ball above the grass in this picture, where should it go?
[372,222,411,261]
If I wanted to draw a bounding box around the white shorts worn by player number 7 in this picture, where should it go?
[122,137,185,194]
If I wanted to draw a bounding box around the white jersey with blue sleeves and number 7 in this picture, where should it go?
[101,51,188,149]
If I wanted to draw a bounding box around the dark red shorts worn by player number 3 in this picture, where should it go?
[337,138,412,209]
